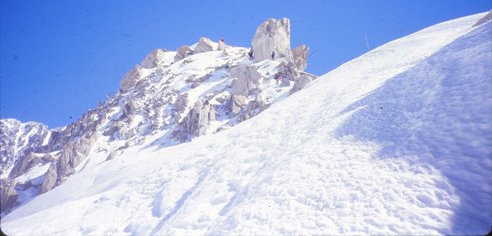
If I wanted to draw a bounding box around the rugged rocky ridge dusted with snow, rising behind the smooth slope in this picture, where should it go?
[0,18,316,214]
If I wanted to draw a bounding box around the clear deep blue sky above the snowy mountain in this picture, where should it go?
[0,0,492,128]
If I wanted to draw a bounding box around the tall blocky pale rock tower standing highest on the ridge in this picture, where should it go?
[251,18,292,62]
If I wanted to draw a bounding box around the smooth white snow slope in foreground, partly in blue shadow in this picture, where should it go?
[2,14,492,235]
